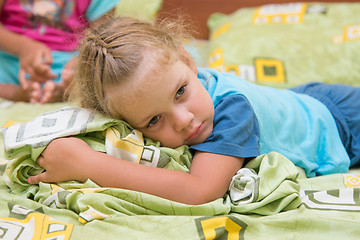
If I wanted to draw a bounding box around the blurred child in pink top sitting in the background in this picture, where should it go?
[0,0,119,103]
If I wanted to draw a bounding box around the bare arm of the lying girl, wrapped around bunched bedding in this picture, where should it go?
[29,138,243,205]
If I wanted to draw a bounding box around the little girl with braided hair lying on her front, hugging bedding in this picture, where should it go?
[29,18,360,204]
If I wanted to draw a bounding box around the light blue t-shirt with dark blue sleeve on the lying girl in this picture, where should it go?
[191,69,350,177]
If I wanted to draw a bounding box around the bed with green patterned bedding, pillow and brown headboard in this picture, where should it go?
[0,0,360,240]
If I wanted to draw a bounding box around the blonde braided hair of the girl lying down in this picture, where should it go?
[70,17,193,119]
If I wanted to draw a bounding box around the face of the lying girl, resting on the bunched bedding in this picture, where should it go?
[110,52,214,148]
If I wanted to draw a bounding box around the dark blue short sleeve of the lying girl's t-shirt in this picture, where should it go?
[190,95,260,158]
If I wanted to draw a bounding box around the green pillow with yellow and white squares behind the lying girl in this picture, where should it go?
[208,2,360,88]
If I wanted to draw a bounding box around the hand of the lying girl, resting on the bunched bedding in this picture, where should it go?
[28,137,94,184]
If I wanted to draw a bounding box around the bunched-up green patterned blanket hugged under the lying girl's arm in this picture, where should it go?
[0,107,300,223]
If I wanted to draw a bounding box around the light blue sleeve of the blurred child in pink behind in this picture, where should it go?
[86,0,121,22]
